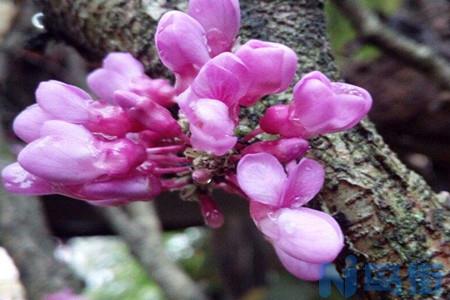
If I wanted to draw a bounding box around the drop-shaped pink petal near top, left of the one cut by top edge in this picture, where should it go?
[155,11,210,93]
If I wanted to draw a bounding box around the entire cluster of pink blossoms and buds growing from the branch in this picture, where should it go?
[2,0,372,280]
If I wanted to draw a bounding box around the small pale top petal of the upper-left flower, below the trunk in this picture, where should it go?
[103,52,144,79]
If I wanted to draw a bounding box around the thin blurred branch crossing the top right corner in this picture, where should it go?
[332,0,450,89]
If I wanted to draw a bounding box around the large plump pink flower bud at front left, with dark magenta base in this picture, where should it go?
[18,120,145,184]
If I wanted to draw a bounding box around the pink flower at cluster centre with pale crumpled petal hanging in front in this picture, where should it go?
[177,53,249,155]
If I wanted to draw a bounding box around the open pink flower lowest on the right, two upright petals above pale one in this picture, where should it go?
[237,153,343,280]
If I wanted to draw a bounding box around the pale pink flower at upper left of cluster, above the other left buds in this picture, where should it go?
[87,52,175,106]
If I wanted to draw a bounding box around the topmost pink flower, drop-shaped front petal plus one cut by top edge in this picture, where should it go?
[155,0,240,94]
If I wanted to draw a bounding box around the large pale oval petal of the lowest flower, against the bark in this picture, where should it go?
[270,207,344,264]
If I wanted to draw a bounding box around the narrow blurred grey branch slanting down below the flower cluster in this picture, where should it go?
[99,202,206,300]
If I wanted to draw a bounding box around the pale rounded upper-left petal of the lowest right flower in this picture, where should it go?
[237,153,287,206]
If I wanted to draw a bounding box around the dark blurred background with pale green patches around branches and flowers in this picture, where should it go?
[0,0,450,300]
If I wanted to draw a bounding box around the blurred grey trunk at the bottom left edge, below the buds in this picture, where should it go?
[0,136,81,300]
